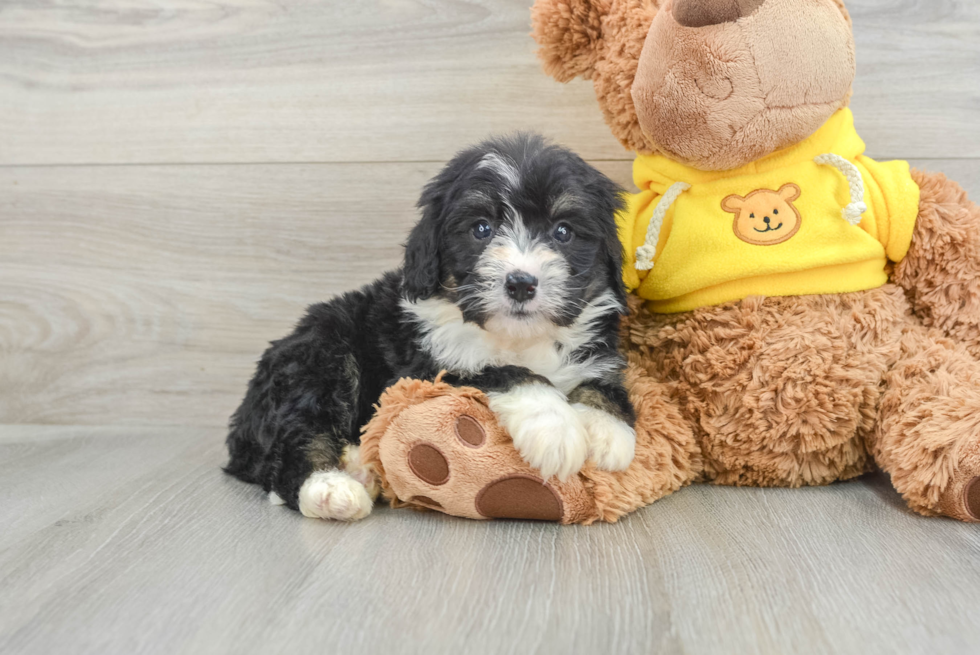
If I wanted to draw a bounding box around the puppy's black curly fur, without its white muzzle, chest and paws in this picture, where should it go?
[225,135,633,509]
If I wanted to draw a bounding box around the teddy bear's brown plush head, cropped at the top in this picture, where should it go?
[532,0,855,170]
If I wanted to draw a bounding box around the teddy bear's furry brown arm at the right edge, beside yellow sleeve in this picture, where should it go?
[894,171,980,359]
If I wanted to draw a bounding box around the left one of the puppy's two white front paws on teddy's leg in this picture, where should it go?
[489,383,589,480]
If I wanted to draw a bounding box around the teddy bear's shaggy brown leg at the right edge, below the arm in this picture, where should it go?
[869,325,980,522]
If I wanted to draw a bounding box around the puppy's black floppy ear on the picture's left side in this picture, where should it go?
[402,181,447,302]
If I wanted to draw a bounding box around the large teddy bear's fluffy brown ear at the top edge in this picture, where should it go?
[531,0,612,82]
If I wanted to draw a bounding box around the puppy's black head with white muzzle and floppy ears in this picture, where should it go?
[405,137,625,335]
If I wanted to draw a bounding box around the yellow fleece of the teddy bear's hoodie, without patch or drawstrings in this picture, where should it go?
[617,109,919,313]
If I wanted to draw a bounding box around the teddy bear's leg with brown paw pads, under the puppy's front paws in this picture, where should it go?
[361,374,700,524]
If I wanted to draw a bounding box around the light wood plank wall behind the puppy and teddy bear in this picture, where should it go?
[0,0,980,427]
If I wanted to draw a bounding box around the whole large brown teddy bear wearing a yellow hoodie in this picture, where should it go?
[362,0,980,523]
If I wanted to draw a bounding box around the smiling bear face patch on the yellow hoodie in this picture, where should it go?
[721,184,803,246]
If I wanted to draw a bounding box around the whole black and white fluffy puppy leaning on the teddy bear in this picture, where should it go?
[226,136,635,520]
